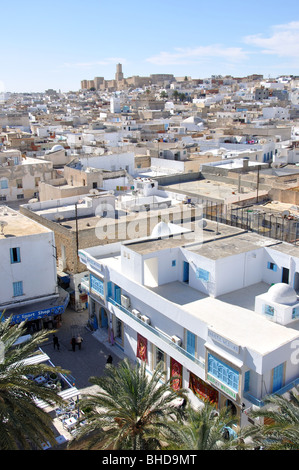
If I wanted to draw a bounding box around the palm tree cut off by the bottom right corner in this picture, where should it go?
[248,391,299,450]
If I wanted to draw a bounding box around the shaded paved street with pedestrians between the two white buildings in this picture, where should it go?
[41,308,124,389]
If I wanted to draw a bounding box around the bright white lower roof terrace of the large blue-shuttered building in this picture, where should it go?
[148,281,298,355]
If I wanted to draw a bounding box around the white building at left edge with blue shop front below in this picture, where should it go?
[0,206,68,329]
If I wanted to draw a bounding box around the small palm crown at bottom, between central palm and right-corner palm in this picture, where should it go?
[178,401,237,451]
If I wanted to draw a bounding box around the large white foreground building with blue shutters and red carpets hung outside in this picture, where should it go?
[79,221,299,425]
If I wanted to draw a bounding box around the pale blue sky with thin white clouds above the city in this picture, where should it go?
[0,0,299,92]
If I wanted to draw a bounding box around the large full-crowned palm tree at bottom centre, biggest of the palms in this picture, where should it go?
[70,359,188,450]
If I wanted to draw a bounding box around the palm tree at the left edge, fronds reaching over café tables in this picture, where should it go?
[0,315,67,450]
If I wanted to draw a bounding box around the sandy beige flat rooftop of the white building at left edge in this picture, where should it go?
[0,206,50,240]
